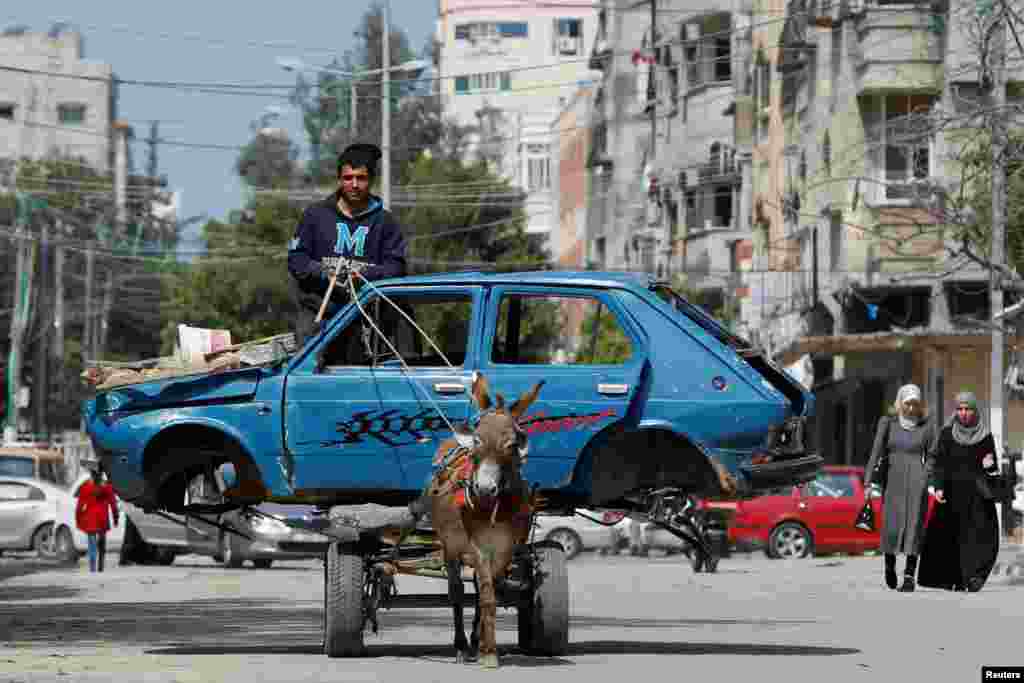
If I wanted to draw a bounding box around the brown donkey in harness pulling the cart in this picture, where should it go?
[428,374,544,668]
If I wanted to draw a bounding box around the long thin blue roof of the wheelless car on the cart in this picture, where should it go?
[374,270,655,288]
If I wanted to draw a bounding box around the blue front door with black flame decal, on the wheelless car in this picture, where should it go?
[285,286,481,492]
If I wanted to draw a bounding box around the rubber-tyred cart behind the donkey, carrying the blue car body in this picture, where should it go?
[313,506,569,657]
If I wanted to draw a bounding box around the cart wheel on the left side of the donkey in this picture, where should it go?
[324,543,365,657]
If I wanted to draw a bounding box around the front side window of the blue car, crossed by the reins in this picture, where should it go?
[321,293,473,368]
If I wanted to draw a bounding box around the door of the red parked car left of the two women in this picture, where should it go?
[798,472,863,549]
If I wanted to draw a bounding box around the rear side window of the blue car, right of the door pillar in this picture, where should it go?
[490,294,633,366]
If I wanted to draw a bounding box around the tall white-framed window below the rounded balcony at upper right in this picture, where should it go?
[879,95,934,200]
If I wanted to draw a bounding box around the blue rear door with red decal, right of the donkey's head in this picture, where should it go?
[480,286,646,488]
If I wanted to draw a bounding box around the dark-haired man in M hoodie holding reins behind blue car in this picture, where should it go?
[288,143,407,343]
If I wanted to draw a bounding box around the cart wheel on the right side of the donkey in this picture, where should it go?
[518,546,569,656]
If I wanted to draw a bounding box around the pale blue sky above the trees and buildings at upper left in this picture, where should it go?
[0,0,437,251]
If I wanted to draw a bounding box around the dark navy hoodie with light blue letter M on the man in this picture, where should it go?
[288,193,406,315]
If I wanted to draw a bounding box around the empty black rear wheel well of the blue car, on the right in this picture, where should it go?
[575,428,735,505]
